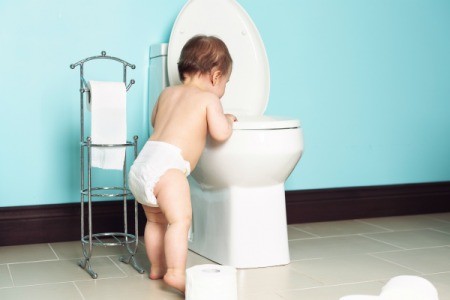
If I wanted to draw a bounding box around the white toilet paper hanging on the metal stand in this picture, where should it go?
[89,81,127,170]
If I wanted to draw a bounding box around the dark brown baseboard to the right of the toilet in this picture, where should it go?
[286,182,450,224]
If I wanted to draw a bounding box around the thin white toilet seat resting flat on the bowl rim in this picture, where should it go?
[233,116,301,130]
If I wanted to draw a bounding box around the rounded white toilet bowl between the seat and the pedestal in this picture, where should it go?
[192,128,303,188]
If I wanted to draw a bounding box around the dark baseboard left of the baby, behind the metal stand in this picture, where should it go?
[0,200,145,246]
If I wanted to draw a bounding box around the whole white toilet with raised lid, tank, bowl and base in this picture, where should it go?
[149,0,303,268]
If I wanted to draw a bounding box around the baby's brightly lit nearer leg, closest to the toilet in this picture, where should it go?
[155,170,192,293]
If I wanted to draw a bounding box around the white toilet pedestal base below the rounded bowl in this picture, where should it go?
[189,178,290,268]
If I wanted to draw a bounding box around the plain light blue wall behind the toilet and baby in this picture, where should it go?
[0,0,450,206]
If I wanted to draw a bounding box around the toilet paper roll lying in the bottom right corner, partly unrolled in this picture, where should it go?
[340,275,439,300]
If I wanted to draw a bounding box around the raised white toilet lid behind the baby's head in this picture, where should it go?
[167,0,270,116]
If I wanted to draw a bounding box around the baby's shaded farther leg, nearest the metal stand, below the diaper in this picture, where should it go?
[142,205,167,279]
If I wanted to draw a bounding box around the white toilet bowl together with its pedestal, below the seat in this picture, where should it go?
[189,128,303,268]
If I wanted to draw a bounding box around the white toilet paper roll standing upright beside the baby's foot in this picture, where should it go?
[186,265,237,300]
